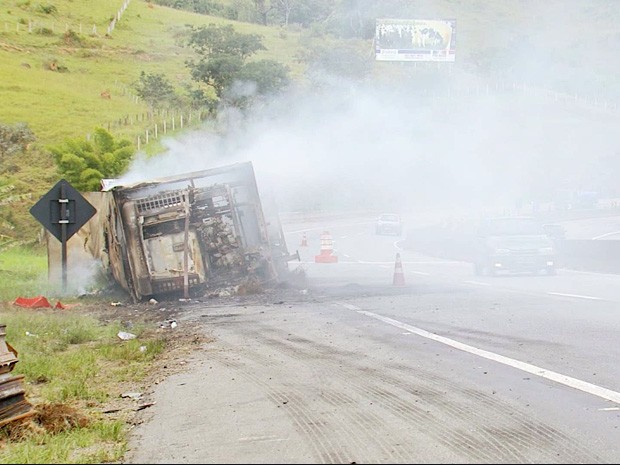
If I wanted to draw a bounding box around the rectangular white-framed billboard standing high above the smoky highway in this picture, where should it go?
[375,19,456,61]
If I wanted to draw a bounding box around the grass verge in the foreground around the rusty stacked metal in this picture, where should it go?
[0,305,166,463]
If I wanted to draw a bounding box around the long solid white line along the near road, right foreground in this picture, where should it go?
[340,304,620,404]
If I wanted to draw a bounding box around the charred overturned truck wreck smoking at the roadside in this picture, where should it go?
[99,162,299,300]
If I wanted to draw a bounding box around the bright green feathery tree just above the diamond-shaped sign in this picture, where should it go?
[50,128,134,191]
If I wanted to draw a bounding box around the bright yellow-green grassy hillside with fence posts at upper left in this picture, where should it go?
[0,0,308,144]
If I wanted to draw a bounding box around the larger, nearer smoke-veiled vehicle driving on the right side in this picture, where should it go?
[474,217,557,276]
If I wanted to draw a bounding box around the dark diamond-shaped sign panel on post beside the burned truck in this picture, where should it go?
[30,179,97,241]
